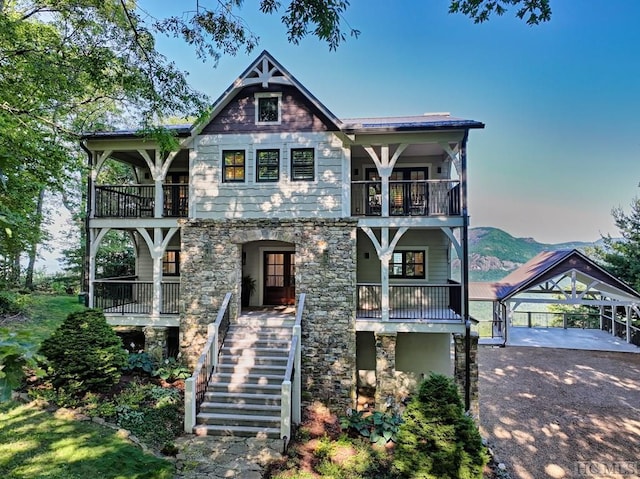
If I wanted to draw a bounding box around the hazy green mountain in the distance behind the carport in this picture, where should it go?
[453,227,600,281]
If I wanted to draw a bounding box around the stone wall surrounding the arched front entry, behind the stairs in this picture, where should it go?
[180,219,357,413]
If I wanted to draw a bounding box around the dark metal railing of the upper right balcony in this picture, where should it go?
[351,180,460,216]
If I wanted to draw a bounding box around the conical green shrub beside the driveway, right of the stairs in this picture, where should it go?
[394,374,487,479]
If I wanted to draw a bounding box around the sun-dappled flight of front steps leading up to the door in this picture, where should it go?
[194,308,295,438]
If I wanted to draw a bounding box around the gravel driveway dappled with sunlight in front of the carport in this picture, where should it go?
[478,347,640,479]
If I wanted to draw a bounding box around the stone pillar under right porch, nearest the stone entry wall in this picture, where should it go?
[375,333,398,412]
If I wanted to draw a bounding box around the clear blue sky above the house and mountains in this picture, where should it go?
[142,0,640,243]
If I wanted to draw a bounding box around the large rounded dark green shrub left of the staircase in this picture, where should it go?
[40,309,127,396]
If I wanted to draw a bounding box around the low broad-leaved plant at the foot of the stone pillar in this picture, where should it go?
[340,411,402,445]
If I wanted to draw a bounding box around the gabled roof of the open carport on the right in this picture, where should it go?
[469,249,640,301]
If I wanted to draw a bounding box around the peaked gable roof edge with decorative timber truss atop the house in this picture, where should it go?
[192,50,342,136]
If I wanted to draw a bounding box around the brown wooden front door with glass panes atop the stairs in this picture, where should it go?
[264,251,296,304]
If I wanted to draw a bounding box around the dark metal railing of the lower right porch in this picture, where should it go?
[356,283,462,321]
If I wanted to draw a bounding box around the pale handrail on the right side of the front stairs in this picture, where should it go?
[280,293,307,443]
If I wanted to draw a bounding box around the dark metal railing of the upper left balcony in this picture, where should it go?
[95,183,189,218]
